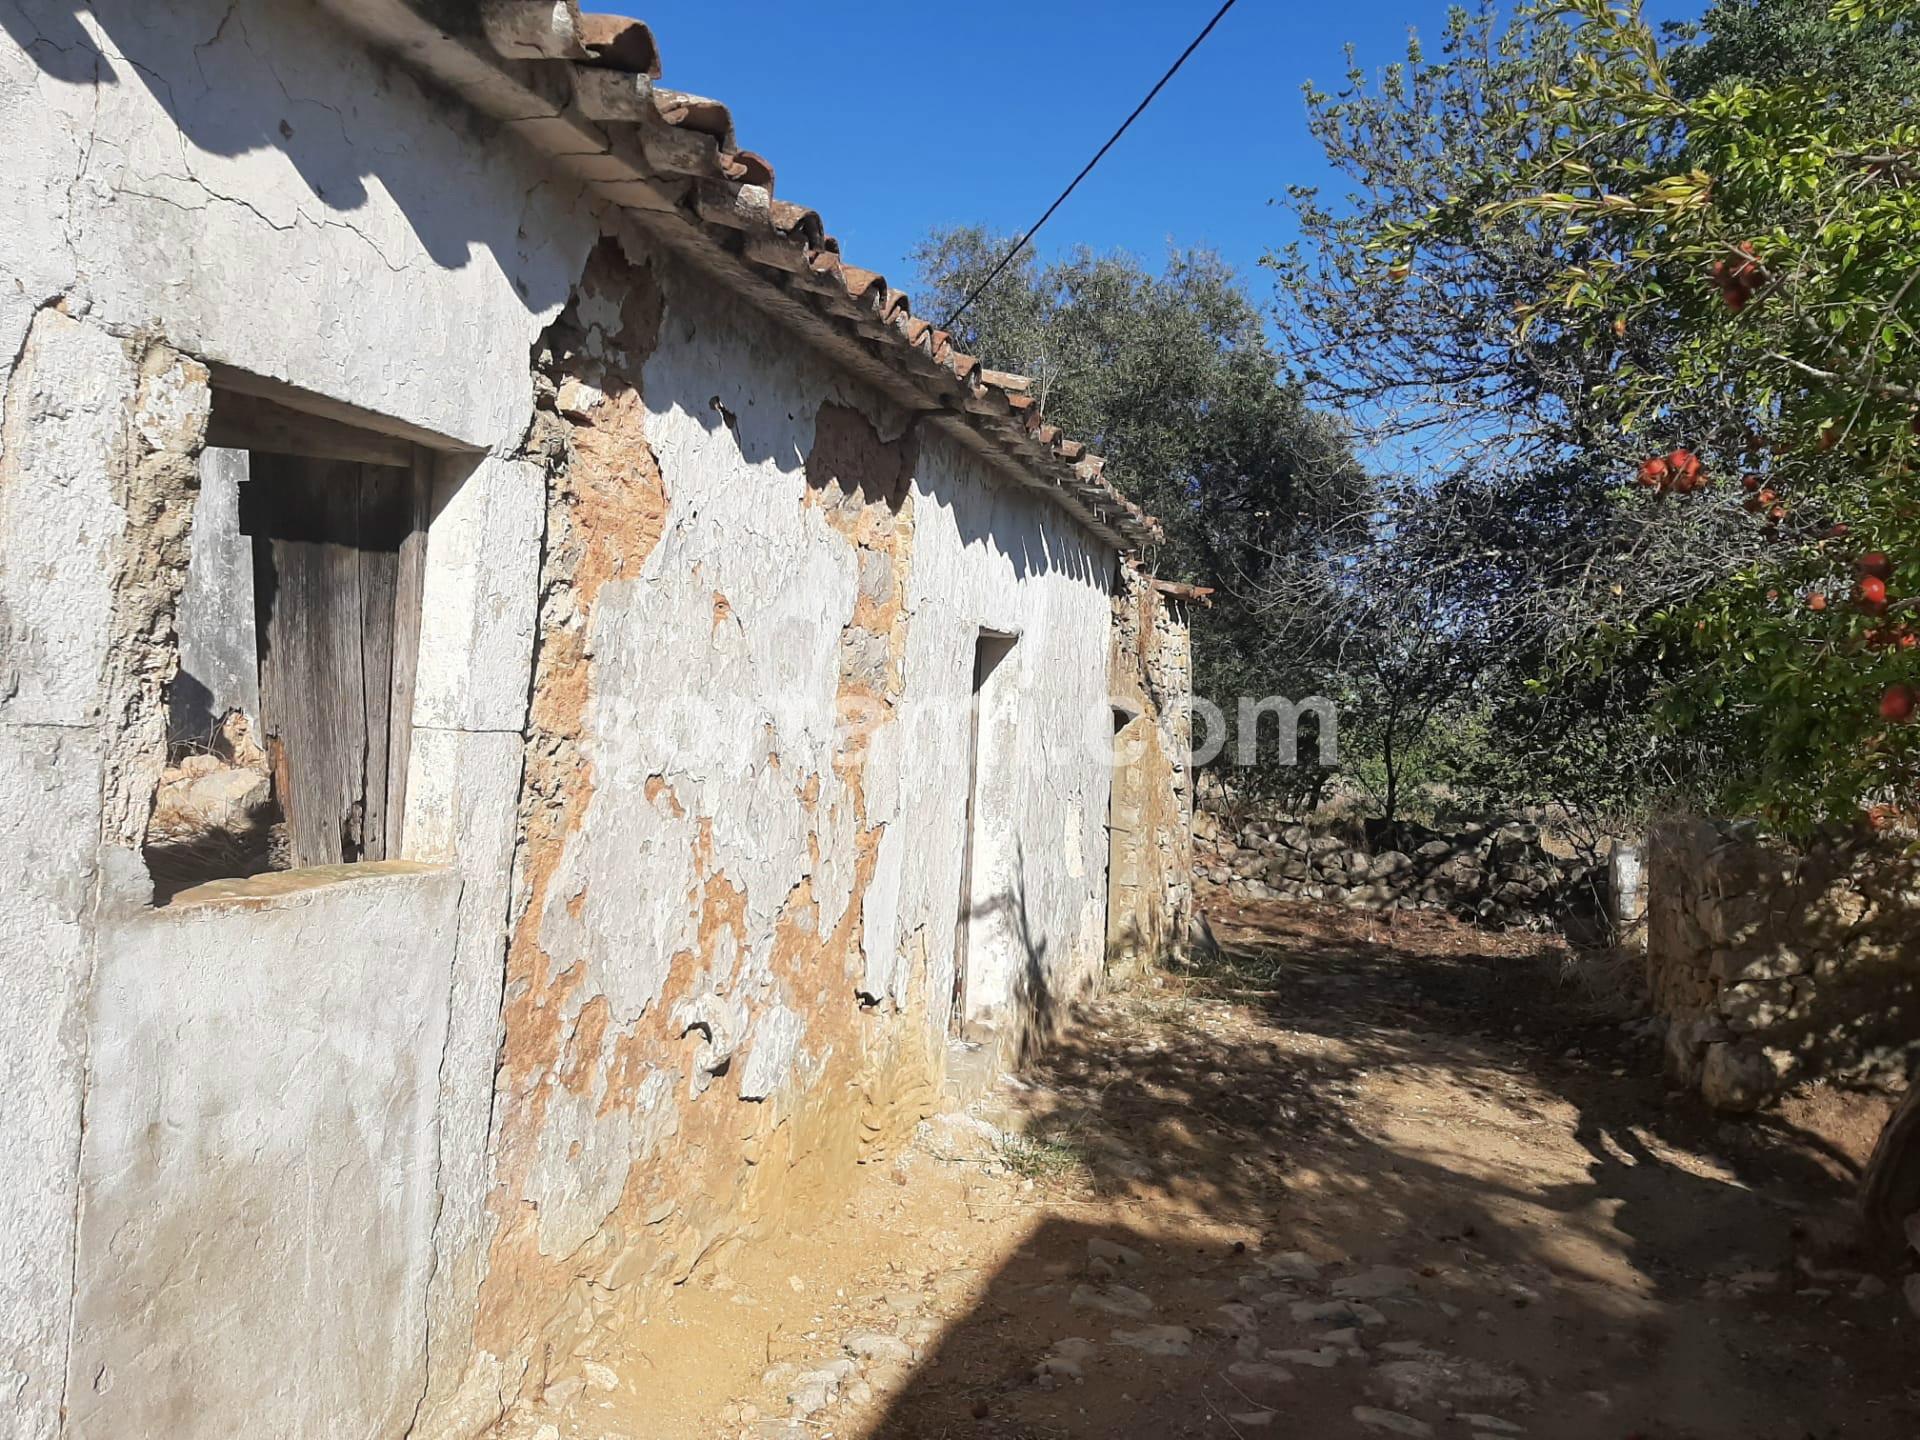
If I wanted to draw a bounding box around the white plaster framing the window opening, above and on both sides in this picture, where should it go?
[0,0,595,1436]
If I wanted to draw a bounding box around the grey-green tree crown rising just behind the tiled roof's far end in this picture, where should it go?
[916,227,1377,806]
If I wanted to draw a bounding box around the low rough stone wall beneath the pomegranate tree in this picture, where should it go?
[1647,820,1920,1112]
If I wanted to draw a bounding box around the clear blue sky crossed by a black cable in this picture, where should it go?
[606,0,1703,311]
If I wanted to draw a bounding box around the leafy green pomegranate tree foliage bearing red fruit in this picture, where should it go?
[1373,0,1920,826]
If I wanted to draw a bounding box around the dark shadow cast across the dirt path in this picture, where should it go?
[868,917,1914,1440]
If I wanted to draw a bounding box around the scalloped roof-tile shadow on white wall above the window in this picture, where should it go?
[0,0,566,293]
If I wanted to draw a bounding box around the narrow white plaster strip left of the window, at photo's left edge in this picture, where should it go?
[0,311,136,1440]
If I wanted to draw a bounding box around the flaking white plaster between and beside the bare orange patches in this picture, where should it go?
[516,265,1114,1254]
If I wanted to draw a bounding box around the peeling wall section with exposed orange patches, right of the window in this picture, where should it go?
[478,244,1112,1428]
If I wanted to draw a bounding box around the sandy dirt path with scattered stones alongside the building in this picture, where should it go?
[528,908,1920,1440]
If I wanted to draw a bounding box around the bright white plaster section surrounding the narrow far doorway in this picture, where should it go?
[887,432,1114,1023]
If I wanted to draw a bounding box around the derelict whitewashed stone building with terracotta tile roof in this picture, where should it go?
[0,0,1188,1440]
